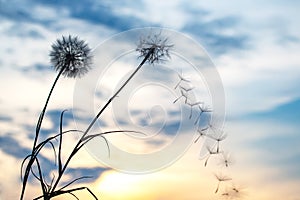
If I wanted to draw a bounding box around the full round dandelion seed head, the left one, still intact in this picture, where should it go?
[50,35,92,78]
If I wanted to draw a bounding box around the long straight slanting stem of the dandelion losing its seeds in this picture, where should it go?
[51,47,155,193]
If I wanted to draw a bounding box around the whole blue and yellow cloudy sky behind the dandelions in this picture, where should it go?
[0,0,300,200]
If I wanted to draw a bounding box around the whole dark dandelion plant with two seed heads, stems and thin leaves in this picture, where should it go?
[20,34,173,200]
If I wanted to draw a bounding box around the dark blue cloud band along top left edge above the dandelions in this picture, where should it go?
[1,0,150,31]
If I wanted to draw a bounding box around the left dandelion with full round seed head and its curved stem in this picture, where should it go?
[20,35,92,200]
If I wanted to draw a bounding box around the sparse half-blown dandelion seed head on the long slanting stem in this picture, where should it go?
[136,33,174,64]
